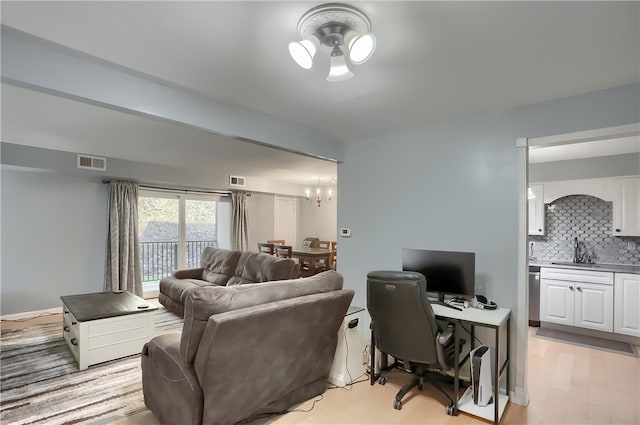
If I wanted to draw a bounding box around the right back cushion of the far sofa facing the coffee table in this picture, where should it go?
[227,251,296,285]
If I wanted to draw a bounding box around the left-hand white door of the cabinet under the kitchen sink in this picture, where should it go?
[540,279,575,325]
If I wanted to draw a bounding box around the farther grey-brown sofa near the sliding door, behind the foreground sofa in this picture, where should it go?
[158,247,300,316]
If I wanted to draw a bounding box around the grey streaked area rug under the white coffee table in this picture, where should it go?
[0,307,182,425]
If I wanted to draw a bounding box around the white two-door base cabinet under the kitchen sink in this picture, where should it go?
[540,267,614,332]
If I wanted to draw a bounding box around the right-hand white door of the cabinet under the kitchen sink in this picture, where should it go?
[575,282,613,332]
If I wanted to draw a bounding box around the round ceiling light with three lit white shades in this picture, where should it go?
[289,3,376,81]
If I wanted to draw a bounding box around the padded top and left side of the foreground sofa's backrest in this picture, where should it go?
[180,270,343,365]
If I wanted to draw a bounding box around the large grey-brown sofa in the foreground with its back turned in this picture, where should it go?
[142,271,354,425]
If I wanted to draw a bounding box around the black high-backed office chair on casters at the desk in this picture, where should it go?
[367,271,463,415]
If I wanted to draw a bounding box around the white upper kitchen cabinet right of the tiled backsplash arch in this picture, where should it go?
[613,177,640,236]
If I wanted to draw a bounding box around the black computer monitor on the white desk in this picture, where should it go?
[402,248,476,301]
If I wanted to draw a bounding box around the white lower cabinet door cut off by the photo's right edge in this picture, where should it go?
[613,273,640,336]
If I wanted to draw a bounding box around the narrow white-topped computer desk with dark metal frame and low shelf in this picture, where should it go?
[431,304,511,424]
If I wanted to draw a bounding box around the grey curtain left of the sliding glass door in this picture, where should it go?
[105,180,142,297]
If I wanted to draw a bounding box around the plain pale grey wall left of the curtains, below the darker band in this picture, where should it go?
[0,165,108,315]
